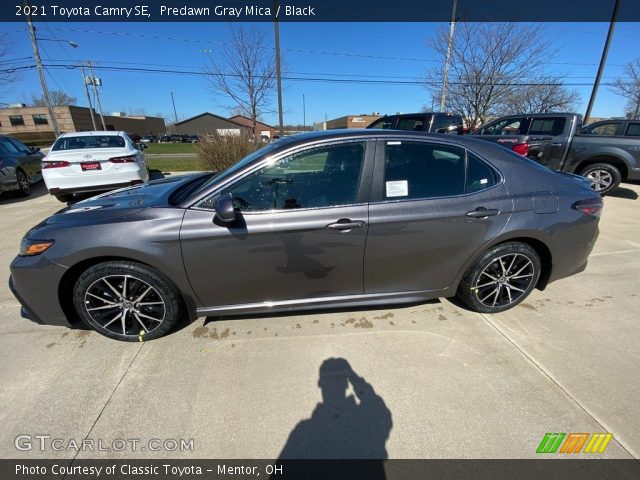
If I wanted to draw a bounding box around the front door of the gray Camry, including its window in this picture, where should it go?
[180,140,375,307]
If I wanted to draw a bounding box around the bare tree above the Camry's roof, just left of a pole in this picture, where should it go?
[205,25,275,134]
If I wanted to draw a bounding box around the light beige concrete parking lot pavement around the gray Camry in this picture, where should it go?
[0,178,640,459]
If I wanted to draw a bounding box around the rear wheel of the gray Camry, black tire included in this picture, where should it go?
[457,242,541,313]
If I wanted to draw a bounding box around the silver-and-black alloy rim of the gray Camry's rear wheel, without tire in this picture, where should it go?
[473,253,535,308]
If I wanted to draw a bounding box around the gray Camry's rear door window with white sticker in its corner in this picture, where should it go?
[384,141,465,199]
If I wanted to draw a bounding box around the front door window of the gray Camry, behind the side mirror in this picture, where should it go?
[215,142,365,212]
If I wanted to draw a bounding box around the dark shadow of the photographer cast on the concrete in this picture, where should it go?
[279,358,392,479]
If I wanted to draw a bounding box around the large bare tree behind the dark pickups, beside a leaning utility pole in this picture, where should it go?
[425,23,577,128]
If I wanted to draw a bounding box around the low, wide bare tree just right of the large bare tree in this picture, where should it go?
[499,78,580,115]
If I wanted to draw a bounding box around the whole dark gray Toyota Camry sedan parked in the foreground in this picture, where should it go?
[10,130,602,341]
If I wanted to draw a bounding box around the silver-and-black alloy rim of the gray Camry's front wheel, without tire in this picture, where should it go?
[84,275,167,336]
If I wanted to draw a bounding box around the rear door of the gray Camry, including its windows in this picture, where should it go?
[364,139,512,294]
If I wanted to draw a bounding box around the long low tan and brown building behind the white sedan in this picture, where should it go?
[0,106,167,144]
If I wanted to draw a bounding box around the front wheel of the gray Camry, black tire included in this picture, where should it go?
[73,261,182,342]
